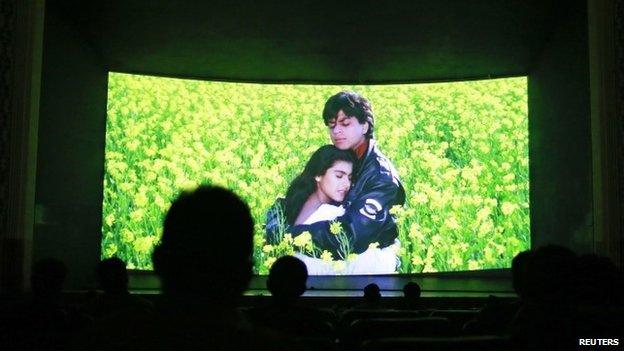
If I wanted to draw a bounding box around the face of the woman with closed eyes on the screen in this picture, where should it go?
[315,161,353,203]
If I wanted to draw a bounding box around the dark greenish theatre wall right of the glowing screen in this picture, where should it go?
[529,3,593,252]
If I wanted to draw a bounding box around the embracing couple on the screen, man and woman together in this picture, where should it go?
[265,92,405,275]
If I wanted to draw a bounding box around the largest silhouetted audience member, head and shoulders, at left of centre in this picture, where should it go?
[75,186,295,350]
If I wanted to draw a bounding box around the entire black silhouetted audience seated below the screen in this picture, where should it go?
[0,192,624,351]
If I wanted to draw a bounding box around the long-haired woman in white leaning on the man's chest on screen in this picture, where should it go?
[266,145,396,275]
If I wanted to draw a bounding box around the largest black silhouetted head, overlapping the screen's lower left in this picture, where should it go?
[152,186,254,302]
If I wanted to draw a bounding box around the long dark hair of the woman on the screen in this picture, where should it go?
[284,145,356,225]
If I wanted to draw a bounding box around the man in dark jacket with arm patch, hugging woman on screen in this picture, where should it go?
[267,91,405,274]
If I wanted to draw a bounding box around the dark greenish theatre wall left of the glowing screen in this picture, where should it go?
[33,2,107,288]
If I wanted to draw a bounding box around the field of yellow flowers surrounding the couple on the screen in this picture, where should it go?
[102,73,530,274]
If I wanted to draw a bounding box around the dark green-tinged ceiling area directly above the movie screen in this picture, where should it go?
[47,0,562,83]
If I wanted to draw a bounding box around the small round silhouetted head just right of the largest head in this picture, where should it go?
[266,256,308,302]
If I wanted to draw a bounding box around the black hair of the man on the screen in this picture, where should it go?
[323,91,375,139]
